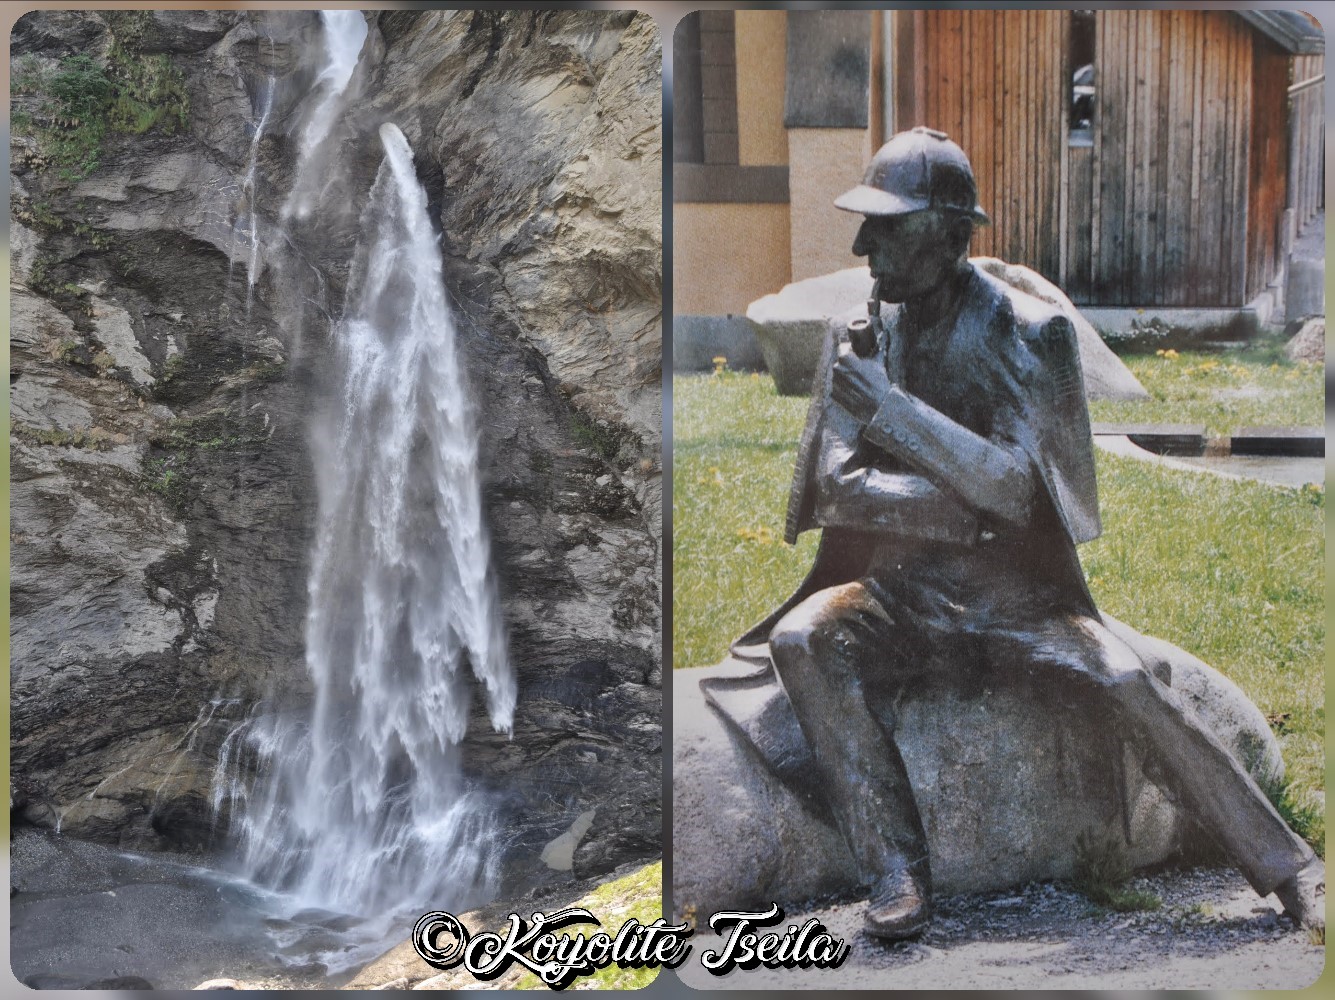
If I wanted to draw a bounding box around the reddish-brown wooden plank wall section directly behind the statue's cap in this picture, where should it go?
[894,9,1067,280]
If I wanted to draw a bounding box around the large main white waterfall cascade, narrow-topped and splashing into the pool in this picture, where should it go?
[215,124,515,913]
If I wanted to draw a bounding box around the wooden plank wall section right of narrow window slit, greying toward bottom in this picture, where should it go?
[1068,11,1268,306]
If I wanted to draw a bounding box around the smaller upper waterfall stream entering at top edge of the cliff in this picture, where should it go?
[283,11,367,219]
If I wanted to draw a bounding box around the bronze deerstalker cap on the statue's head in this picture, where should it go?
[834,126,992,226]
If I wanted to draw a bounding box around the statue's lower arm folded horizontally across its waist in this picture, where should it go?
[816,395,979,542]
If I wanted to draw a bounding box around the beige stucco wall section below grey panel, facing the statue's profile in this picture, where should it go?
[788,128,872,282]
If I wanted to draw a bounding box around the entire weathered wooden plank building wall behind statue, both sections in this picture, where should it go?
[894,9,1297,306]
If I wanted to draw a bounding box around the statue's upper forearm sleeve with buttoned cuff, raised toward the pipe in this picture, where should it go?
[862,386,1037,527]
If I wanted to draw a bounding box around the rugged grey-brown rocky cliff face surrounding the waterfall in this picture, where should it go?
[11,11,662,885]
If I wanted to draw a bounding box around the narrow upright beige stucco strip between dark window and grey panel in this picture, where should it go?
[734,11,788,167]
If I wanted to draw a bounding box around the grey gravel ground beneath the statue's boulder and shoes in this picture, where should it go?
[678,868,1326,991]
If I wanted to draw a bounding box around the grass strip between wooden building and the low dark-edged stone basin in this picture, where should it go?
[1089,343,1326,437]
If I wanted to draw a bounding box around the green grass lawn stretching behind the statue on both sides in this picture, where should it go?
[673,371,1326,838]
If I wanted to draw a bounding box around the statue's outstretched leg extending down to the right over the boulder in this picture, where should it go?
[992,614,1324,919]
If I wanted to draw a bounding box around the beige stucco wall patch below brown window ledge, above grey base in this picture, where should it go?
[672,202,789,316]
